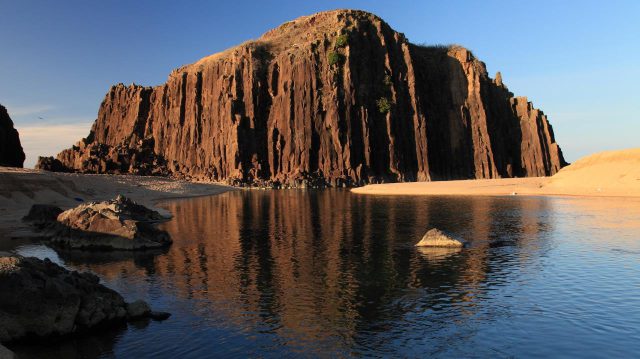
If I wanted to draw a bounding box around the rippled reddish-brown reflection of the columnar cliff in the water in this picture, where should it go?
[81,190,550,352]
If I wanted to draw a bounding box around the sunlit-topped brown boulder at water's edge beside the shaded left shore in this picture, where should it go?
[50,196,172,250]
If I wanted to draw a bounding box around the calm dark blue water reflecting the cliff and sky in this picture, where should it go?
[8,190,640,358]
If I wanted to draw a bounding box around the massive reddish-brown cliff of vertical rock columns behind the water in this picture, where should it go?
[44,10,565,186]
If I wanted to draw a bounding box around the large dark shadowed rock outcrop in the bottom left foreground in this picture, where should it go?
[0,253,166,343]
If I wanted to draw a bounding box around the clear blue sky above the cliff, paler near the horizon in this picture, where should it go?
[0,0,640,166]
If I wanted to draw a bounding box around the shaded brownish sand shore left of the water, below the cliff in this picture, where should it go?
[0,167,234,247]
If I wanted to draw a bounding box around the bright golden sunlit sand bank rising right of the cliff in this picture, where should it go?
[352,148,640,197]
